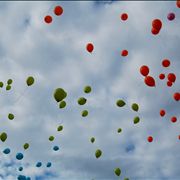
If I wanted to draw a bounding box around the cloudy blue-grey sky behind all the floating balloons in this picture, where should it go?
[0,1,180,180]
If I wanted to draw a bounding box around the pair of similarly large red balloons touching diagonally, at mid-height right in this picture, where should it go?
[139,65,156,87]
